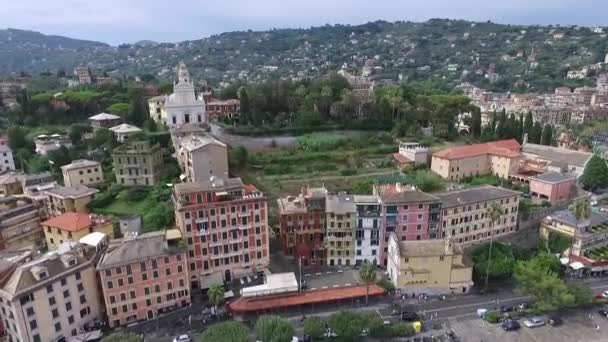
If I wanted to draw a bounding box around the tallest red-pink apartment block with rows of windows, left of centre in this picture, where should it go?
[174,177,269,289]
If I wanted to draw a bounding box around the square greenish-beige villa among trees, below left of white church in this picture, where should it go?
[112,141,163,185]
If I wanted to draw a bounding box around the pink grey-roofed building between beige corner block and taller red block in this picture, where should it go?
[97,229,191,328]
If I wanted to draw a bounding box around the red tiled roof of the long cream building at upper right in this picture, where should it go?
[433,139,521,159]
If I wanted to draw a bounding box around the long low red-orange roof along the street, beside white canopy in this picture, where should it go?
[228,285,384,313]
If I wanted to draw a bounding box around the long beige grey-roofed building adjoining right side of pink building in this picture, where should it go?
[434,185,520,244]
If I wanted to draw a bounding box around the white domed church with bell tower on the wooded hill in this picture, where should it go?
[165,63,207,127]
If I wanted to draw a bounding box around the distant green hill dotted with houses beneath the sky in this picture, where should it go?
[0,19,608,91]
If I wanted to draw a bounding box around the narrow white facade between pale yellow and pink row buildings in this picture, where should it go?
[355,195,382,265]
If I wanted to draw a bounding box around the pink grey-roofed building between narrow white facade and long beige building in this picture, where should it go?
[374,184,441,267]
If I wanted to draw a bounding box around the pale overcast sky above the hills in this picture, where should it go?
[0,0,608,45]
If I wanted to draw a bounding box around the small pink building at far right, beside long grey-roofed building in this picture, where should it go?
[530,172,576,203]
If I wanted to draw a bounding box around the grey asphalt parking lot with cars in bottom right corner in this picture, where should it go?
[446,309,608,342]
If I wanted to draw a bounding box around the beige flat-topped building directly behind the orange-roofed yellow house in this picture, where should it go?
[46,185,99,216]
